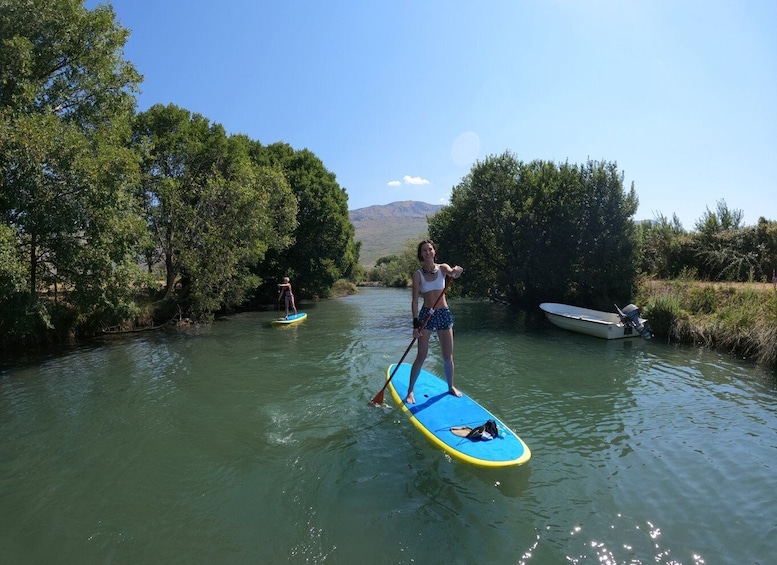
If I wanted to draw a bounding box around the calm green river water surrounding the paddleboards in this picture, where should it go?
[0,289,777,564]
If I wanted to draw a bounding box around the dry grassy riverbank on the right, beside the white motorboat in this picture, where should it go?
[635,280,777,370]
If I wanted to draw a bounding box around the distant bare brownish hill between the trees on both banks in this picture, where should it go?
[349,200,442,267]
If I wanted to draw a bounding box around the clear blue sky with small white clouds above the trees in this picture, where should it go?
[85,0,777,230]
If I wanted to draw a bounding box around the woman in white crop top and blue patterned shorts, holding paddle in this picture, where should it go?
[405,239,464,404]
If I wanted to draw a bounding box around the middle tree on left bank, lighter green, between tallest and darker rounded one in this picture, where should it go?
[135,105,296,318]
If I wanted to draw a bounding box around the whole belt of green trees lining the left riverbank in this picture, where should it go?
[0,0,359,343]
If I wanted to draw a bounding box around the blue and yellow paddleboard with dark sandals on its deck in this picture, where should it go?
[386,363,531,467]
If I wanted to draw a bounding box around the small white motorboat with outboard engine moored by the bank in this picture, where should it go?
[540,302,653,339]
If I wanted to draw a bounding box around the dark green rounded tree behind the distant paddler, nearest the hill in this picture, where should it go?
[253,143,359,296]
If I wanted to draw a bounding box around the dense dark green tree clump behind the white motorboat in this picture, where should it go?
[429,152,637,303]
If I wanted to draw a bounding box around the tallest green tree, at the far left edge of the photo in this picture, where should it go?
[0,0,142,340]
